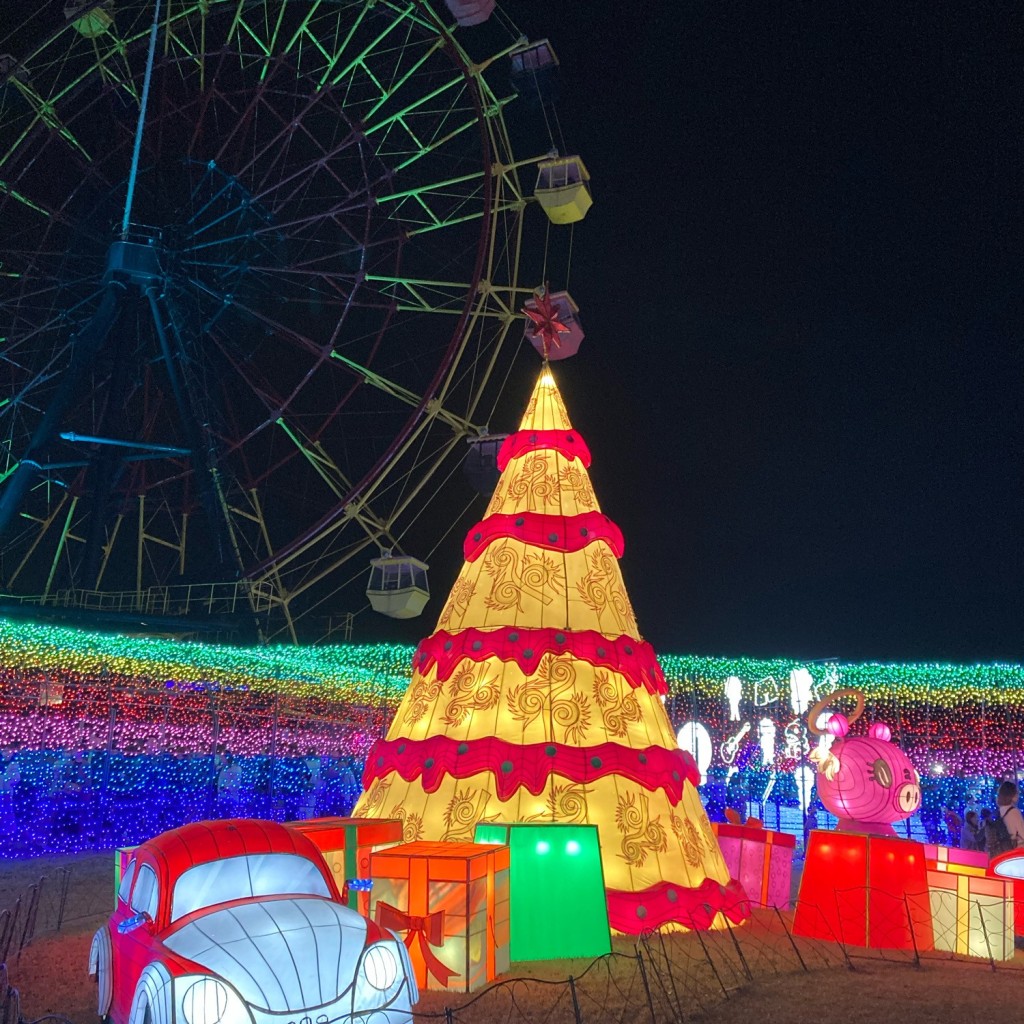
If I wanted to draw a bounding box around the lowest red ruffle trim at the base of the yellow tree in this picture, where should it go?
[606,879,751,935]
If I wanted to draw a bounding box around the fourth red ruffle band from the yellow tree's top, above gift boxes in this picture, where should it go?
[362,736,700,804]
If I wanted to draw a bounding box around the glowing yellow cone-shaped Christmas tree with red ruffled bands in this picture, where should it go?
[354,354,749,933]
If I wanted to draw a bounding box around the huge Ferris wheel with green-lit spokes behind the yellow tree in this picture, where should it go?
[0,0,581,639]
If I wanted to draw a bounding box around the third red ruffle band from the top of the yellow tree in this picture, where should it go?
[413,626,669,695]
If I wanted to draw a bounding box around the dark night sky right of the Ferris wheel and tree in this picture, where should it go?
[485,0,1024,660]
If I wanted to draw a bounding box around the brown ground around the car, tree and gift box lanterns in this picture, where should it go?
[0,853,1024,1024]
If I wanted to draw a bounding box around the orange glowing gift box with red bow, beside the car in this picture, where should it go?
[370,842,509,992]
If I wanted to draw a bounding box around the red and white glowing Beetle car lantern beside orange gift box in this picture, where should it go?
[89,819,419,1024]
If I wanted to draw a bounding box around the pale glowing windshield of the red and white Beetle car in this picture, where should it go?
[171,853,331,921]
